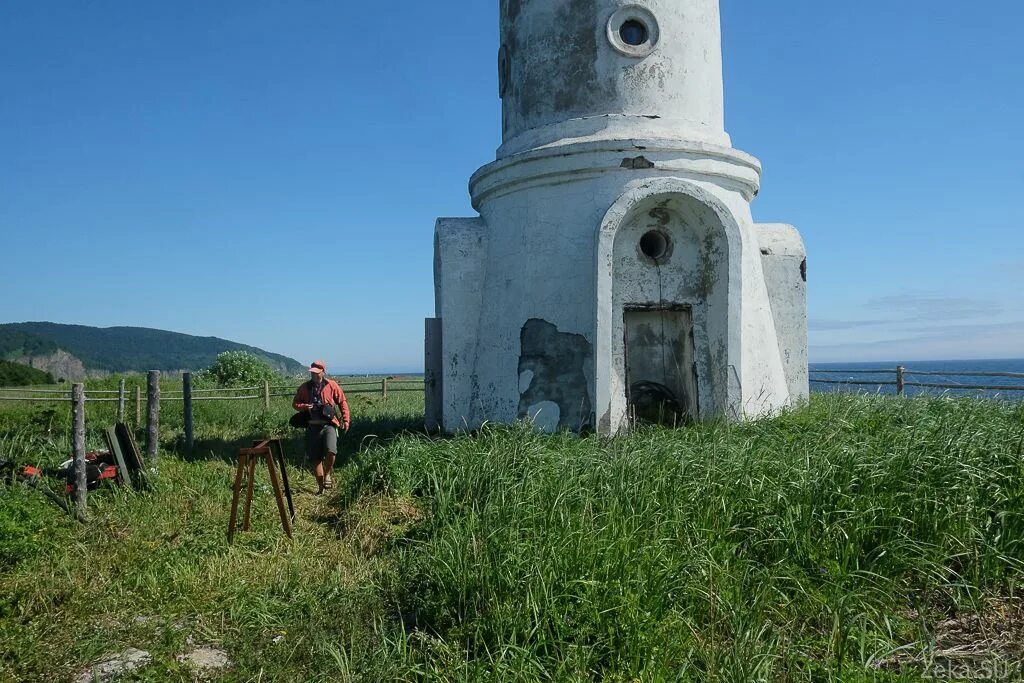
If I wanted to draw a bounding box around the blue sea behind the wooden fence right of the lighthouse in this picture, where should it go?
[810,358,1024,400]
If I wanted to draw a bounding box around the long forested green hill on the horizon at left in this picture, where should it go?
[0,323,305,374]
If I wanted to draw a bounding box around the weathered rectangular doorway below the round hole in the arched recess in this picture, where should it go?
[624,307,698,426]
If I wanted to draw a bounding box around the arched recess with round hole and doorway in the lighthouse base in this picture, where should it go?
[595,178,740,432]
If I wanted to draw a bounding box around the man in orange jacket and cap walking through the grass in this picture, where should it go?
[292,360,349,496]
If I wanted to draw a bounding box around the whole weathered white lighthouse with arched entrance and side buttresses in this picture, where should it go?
[427,0,808,433]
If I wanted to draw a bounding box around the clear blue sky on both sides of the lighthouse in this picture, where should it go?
[0,0,1024,371]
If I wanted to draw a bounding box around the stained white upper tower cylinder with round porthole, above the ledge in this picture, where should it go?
[499,0,729,157]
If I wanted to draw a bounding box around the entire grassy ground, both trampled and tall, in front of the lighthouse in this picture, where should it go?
[0,385,1024,682]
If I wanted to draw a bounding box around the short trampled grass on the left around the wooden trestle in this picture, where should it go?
[0,385,423,681]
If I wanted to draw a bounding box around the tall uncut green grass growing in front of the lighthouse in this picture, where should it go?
[358,396,1024,681]
